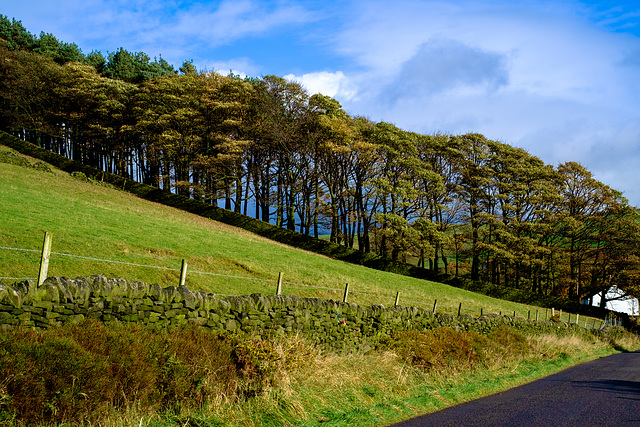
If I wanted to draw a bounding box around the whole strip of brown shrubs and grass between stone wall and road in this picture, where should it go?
[0,321,640,426]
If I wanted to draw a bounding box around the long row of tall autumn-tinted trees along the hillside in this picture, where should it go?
[0,17,640,301]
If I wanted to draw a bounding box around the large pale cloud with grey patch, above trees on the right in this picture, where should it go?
[320,0,640,205]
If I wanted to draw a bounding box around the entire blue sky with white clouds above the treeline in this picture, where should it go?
[0,0,640,206]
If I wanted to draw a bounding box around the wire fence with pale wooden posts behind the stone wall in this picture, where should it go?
[0,237,618,328]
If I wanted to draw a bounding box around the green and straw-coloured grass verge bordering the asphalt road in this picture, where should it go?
[229,335,638,426]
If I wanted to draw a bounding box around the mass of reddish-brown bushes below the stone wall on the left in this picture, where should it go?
[0,321,311,425]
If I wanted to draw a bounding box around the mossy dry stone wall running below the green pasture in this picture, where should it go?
[0,275,576,351]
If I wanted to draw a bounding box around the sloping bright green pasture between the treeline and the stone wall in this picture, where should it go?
[0,147,564,316]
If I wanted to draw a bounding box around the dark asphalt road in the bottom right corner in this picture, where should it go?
[395,352,640,427]
